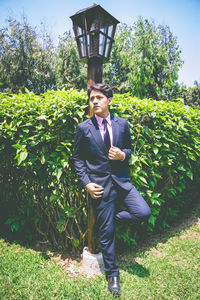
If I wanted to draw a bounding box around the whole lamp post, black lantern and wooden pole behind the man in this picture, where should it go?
[70,4,119,254]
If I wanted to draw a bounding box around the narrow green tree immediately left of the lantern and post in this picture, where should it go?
[54,32,87,89]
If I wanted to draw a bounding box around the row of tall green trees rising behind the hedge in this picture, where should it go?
[0,17,200,106]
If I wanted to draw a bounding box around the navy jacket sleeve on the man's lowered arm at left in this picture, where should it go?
[73,125,91,186]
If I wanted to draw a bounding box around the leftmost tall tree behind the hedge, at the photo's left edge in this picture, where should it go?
[0,17,55,94]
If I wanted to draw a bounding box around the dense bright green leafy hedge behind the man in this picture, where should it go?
[0,90,200,249]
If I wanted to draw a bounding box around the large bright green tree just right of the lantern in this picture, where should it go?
[105,17,183,99]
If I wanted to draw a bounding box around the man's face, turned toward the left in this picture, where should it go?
[89,90,112,118]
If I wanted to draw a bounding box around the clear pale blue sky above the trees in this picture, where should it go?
[0,0,200,87]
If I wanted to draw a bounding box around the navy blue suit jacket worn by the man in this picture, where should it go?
[73,115,133,199]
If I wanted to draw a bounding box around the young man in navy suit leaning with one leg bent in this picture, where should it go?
[73,83,150,297]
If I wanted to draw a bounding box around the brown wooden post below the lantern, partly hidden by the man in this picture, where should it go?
[87,57,103,254]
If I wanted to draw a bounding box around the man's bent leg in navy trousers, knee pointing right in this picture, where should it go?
[115,186,151,221]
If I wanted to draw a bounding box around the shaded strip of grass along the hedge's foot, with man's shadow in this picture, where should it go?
[0,203,200,277]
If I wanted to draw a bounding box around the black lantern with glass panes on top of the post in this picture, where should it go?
[70,4,119,61]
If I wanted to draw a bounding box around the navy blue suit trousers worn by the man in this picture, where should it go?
[93,183,151,277]
